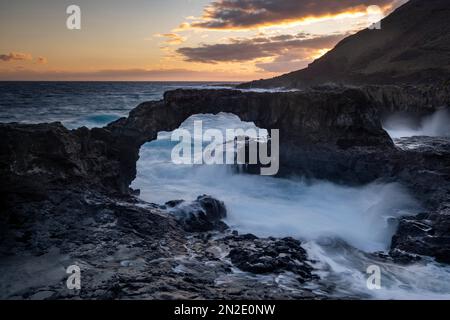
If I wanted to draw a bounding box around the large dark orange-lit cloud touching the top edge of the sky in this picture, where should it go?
[185,0,404,30]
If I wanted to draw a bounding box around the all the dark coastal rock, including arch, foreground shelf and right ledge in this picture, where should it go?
[0,87,450,299]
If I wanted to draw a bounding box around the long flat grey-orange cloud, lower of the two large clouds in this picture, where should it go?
[177,33,345,63]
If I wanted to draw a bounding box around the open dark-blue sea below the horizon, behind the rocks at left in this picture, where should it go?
[0,82,232,129]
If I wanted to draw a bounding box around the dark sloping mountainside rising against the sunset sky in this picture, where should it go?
[241,0,450,88]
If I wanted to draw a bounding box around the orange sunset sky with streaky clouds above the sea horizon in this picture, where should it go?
[0,0,407,81]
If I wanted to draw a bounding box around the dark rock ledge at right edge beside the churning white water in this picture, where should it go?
[391,137,450,263]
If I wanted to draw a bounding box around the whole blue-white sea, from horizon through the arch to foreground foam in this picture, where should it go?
[0,82,450,299]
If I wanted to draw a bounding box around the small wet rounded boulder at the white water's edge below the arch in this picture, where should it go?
[166,195,228,232]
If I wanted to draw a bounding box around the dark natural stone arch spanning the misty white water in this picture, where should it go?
[105,89,394,192]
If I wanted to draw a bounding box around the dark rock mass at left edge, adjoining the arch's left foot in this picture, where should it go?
[0,123,132,195]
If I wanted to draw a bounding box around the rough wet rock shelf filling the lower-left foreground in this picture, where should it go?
[0,187,316,300]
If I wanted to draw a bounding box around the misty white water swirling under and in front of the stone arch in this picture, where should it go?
[132,113,416,252]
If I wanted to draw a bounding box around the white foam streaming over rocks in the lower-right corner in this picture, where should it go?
[304,239,450,300]
